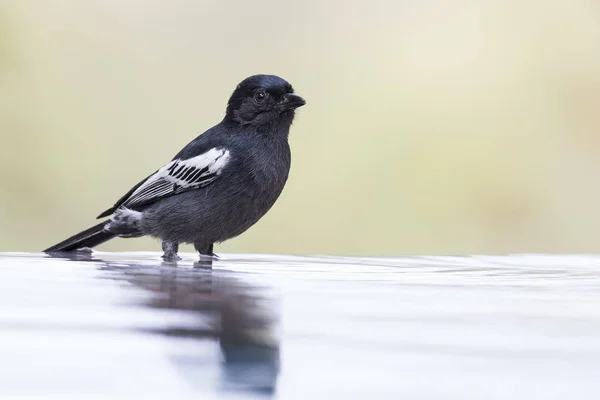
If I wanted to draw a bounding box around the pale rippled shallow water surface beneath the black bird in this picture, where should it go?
[0,252,600,400]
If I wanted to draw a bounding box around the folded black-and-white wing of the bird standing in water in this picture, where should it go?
[98,147,230,218]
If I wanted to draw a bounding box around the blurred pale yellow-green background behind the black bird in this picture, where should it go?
[0,0,600,255]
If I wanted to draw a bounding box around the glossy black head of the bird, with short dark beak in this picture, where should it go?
[225,75,306,128]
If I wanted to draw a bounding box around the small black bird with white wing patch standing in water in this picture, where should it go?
[44,74,306,261]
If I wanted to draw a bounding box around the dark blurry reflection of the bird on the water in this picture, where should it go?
[47,252,280,397]
